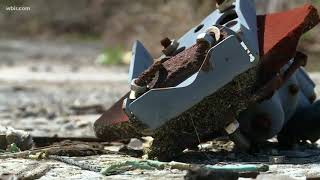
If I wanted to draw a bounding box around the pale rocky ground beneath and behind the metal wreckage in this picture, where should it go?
[0,39,320,179]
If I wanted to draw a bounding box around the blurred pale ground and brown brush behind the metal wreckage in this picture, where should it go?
[0,0,320,136]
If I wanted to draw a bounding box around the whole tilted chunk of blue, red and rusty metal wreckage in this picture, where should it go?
[94,0,320,160]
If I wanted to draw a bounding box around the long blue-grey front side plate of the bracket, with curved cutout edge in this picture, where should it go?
[128,35,254,128]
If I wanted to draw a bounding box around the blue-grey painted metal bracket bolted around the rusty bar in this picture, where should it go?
[124,0,259,128]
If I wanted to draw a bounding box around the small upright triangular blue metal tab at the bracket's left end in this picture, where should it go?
[128,41,153,85]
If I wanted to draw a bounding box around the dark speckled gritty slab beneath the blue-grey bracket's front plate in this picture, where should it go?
[148,68,257,161]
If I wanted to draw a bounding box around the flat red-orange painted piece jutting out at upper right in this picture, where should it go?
[258,5,319,73]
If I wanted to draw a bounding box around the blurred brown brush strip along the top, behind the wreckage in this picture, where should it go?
[0,0,320,70]
